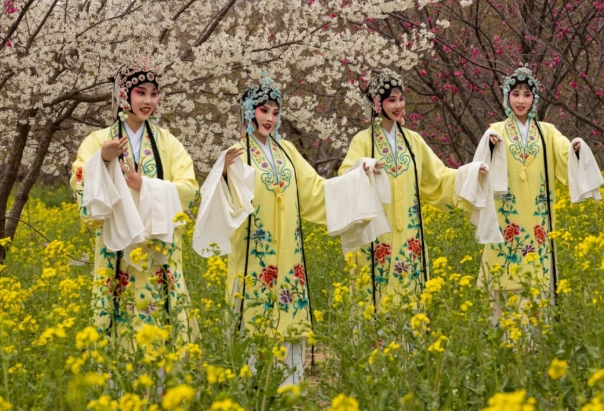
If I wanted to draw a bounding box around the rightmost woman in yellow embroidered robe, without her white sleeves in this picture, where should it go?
[479,67,580,308]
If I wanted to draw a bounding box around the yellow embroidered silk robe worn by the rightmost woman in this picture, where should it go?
[478,115,570,291]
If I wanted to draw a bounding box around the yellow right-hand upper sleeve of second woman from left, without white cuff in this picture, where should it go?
[279,141,327,225]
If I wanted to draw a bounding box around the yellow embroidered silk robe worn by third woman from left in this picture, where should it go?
[339,125,457,307]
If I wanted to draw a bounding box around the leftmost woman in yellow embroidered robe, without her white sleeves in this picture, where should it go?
[71,56,199,346]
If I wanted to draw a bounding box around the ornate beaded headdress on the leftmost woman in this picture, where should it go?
[111,54,159,120]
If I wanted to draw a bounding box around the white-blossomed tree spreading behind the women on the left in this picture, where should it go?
[0,0,444,260]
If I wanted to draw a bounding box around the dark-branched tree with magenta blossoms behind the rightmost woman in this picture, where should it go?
[368,0,604,166]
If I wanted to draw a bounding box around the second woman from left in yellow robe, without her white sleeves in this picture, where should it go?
[205,77,380,386]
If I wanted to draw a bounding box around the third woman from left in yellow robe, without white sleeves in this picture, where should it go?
[339,70,486,309]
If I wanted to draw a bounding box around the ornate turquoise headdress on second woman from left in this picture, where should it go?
[239,71,283,140]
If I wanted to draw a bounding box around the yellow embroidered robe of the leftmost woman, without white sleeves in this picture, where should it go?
[71,122,199,340]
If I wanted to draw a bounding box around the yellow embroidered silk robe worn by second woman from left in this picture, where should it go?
[227,137,326,335]
